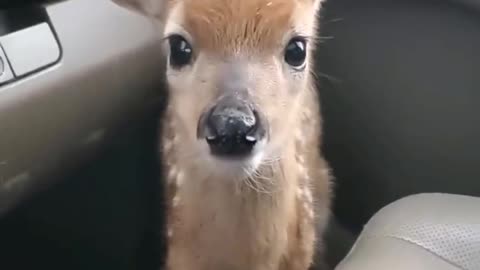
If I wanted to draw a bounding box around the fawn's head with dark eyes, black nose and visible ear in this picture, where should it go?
[113,0,322,179]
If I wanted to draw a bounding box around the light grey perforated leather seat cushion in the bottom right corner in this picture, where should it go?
[336,194,480,270]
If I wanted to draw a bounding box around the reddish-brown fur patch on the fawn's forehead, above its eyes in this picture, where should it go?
[185,0,295,54]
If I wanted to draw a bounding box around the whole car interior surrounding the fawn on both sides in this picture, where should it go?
[0,0,480,270]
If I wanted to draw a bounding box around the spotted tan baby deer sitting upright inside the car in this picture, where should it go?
[113,0,330,270]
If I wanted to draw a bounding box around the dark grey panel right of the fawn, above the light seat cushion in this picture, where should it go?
[317,0,480,233]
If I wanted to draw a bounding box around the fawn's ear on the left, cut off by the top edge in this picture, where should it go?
[112,0,169,20]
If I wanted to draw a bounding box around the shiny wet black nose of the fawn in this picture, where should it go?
[199,97,265,157]
